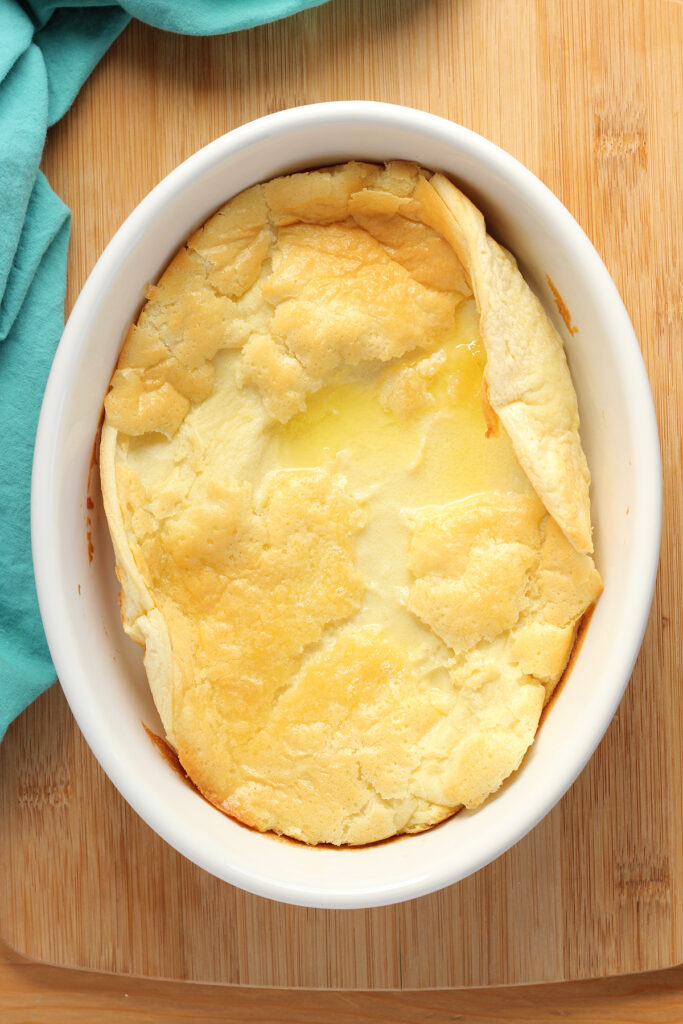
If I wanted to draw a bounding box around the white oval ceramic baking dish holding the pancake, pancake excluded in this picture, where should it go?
[32,102,661,907]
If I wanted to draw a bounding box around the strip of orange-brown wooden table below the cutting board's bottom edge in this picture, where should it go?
[0,944,683,1024]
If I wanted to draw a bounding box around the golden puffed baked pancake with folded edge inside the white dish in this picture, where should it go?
[100,163,601,845]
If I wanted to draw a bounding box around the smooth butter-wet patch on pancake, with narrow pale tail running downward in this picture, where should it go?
[268,300,530,663]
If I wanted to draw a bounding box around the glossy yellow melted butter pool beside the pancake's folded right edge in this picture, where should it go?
[273,300,529,508]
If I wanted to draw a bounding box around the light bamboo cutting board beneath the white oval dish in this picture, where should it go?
[0,0,683,988]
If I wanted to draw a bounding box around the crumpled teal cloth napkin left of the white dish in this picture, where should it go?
[0,0,326,739]
